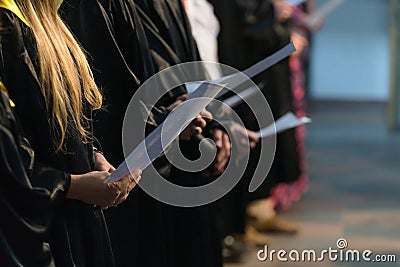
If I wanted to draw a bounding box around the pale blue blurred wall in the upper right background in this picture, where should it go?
[310,0,390,101]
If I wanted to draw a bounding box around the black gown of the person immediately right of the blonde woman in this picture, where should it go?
[59,0,176,267]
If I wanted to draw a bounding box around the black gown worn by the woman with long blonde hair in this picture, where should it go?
[0,9,113,267]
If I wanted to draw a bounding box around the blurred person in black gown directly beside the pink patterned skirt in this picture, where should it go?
[211,0,300,253]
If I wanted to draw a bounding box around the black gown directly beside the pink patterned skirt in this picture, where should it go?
[211,0,300,199]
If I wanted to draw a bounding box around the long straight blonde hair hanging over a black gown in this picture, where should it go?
[14,0,102,150]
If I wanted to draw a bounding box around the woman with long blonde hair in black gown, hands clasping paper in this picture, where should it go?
[0,0,140,267]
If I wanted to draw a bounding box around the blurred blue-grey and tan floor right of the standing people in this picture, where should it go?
[226,103,400,267]
